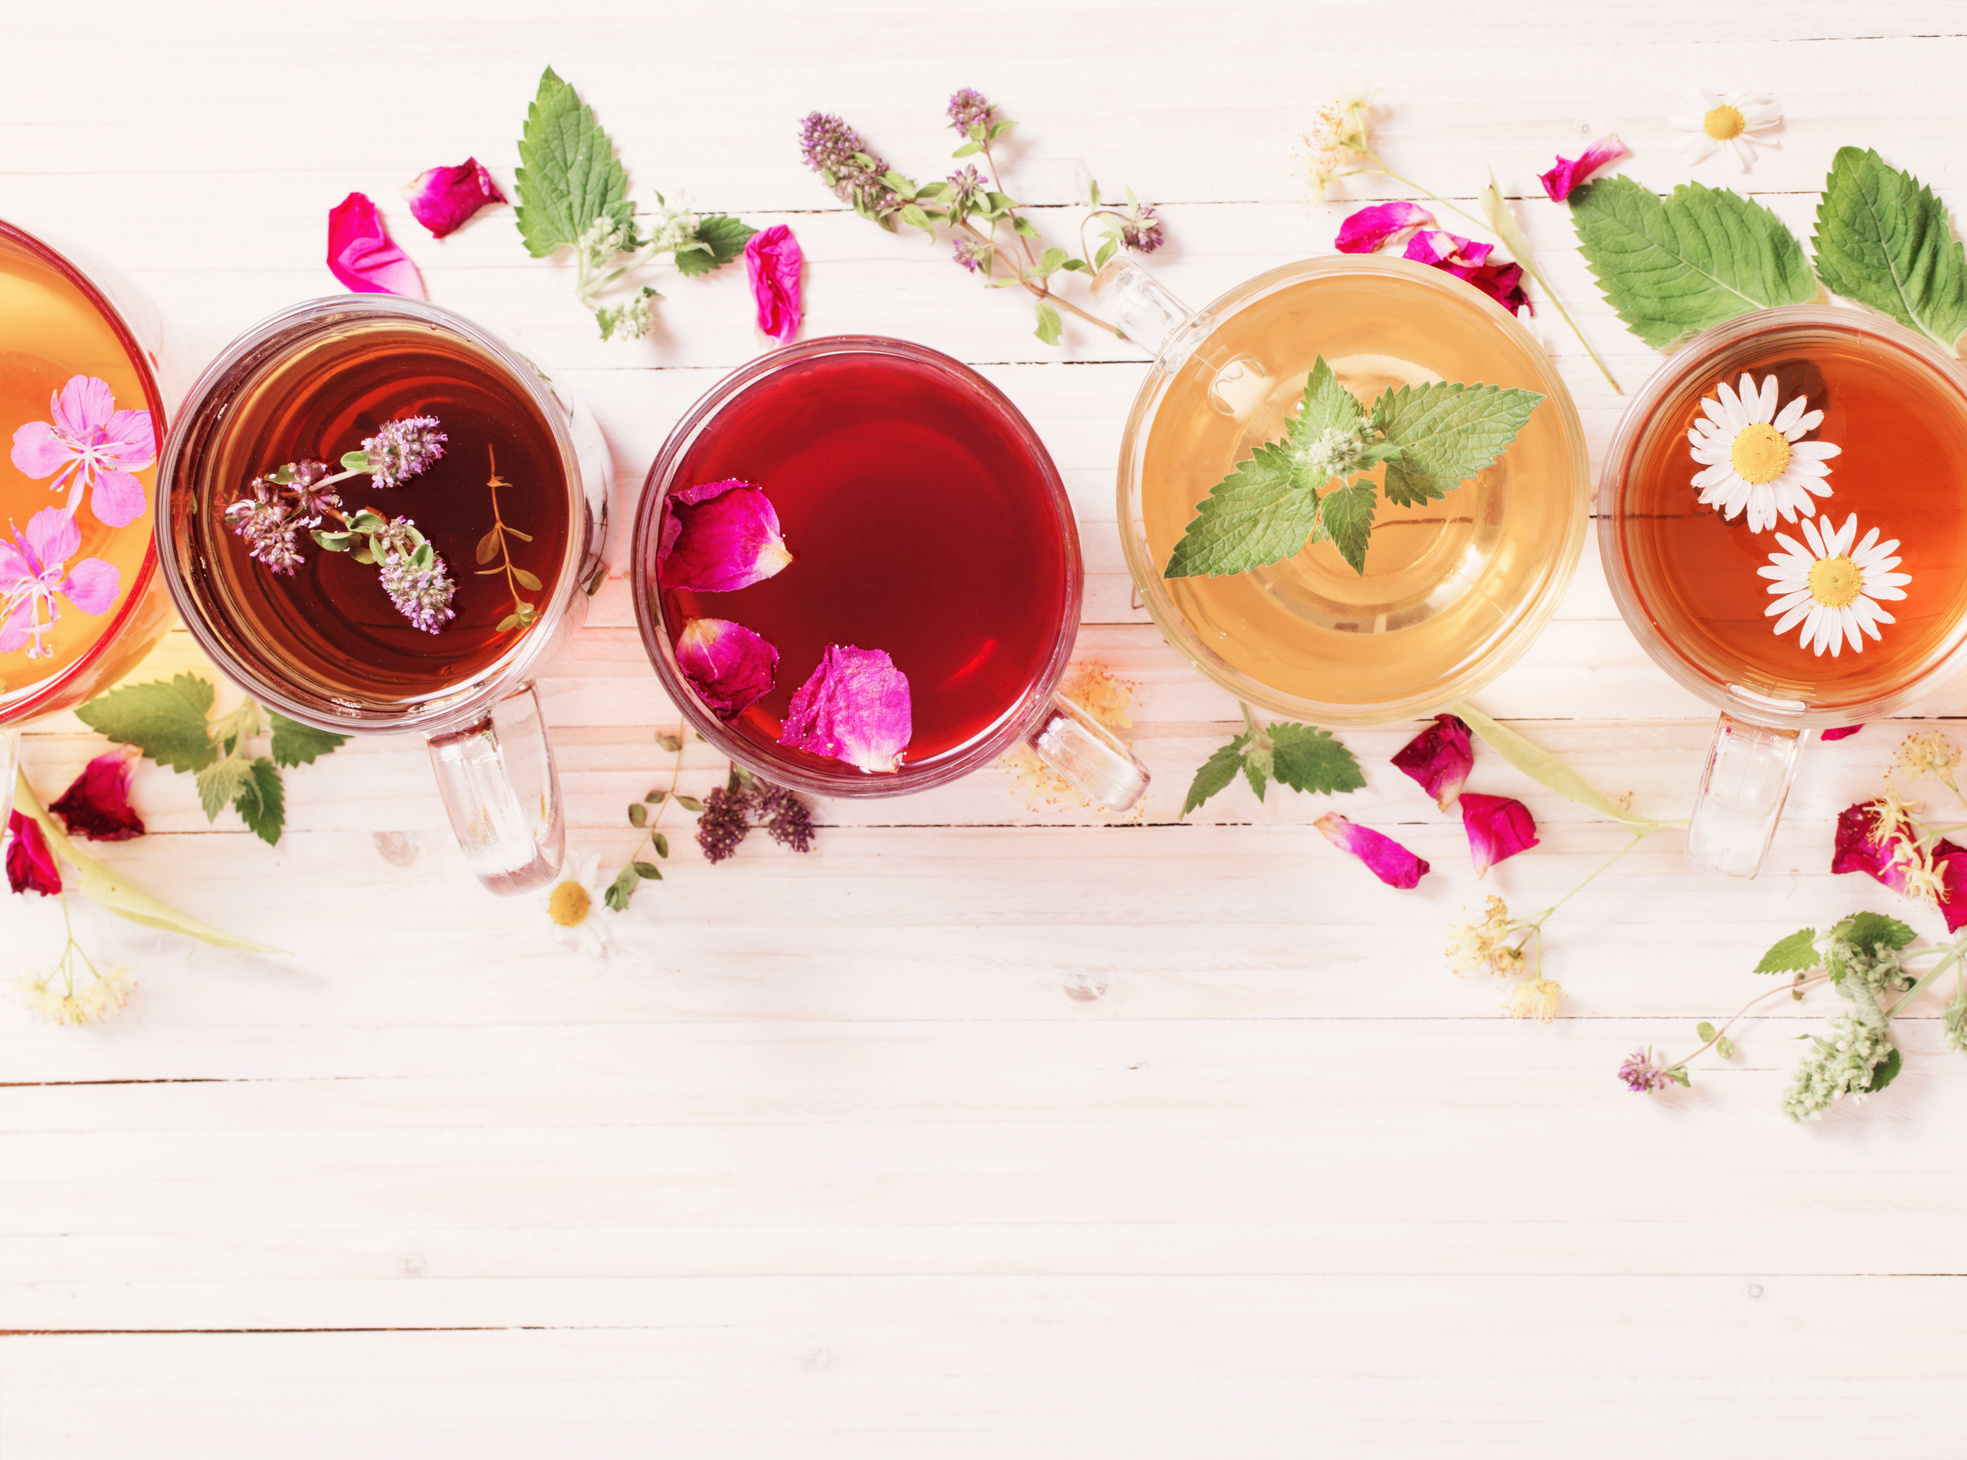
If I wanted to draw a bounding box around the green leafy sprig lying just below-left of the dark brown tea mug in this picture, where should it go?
[75,675,348,846]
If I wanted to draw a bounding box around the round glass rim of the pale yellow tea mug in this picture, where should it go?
[1115,254,1591,730]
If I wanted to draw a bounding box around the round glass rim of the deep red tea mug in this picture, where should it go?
[629,335,1086,799]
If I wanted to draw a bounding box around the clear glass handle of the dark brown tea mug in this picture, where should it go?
[425,685,566,895]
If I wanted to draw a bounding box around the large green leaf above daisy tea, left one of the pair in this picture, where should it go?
[1572,177,1818,350]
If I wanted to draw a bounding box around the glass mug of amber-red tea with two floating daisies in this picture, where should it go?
[1597,305,1967,878]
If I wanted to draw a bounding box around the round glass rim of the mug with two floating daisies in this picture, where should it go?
[1595,303,1967,730]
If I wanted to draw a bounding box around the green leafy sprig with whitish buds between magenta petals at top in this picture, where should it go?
[515,67,757,340]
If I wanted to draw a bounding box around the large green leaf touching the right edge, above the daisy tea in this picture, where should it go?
[1810,148,1967,350]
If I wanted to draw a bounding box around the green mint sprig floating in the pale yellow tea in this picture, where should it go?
[1162,356,1544,578]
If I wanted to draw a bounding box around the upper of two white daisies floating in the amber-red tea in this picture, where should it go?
[1688,374,1841,533]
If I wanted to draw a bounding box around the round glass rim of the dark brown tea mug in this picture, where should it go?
[153,293,582,734]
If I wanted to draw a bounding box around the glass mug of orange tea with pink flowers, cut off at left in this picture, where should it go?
[0,220,191,828]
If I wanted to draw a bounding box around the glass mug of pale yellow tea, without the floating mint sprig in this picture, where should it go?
[1092,256,1591,728]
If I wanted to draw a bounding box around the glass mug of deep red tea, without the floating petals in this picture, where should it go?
[631,335,1147,811]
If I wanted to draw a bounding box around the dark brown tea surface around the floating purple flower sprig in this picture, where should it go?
[191,321,572,712]
